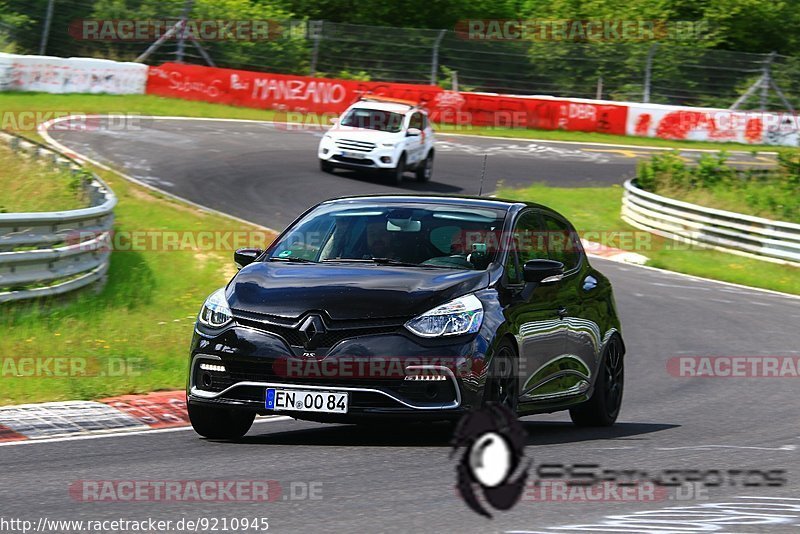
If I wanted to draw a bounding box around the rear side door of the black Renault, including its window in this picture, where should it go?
[542,211,601,394]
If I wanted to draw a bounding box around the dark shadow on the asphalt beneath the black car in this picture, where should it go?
[230,421,680,447]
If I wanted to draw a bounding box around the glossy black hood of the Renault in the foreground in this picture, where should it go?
[226,262,489,320]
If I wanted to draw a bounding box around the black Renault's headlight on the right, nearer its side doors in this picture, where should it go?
[406,294,483,337]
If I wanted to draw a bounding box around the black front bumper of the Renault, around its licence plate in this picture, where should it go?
[187,325,486,421]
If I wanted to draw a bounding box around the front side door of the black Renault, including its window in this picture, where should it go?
[503,209,565,403]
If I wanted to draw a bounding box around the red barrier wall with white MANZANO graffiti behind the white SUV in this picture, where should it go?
[147,63,627,135]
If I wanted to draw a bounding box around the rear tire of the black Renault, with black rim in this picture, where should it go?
[569,338,625,426]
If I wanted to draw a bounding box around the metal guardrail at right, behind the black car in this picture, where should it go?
[622,180,800,266]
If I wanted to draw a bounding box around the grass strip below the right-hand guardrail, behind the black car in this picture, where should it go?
[497,185,800,295]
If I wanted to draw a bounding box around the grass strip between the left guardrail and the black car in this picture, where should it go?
[0,158,273,405]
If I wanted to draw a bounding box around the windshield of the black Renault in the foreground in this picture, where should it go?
[267,203,505,269]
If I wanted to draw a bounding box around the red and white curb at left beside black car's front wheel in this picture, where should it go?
[0,391,189,443]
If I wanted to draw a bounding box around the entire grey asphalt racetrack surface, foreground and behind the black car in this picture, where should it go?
[7,121,800,534]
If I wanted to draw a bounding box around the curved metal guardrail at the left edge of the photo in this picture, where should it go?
[0,132,117,303]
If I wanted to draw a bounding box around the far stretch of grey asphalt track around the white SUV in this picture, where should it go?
[45,118,773,228]
